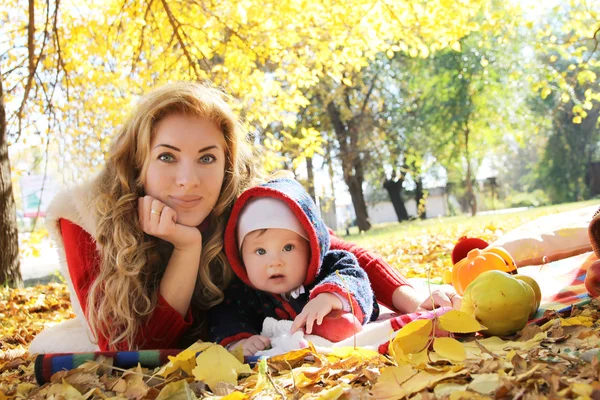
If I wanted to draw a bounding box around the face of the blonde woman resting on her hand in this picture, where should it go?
[144,114,226,226]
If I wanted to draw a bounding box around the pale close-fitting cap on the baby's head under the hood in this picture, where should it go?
[237,197,308,249]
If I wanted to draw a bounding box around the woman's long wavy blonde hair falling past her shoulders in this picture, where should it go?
[87,82,260,349]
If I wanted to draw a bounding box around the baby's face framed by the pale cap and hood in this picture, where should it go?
[242,229,310,294]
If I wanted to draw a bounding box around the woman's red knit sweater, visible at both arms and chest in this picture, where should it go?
[60,218,408,351]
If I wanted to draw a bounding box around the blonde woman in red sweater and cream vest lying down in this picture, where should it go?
[30,83,460,353]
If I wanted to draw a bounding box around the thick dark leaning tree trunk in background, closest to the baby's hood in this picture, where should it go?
[327,102,371,232]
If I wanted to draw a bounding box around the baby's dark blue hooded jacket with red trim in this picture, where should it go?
[208,178,379,345]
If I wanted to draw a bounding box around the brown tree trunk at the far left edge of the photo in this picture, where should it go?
[0,71,23,287]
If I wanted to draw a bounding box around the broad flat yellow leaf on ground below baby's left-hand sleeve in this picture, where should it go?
[192,345,252,388]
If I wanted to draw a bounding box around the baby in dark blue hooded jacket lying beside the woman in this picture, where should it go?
[208,178,379,355]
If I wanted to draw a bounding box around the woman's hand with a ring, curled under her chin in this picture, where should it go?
[138,196,202,250]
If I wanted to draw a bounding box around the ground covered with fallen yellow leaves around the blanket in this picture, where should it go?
[0,202,600,400]
